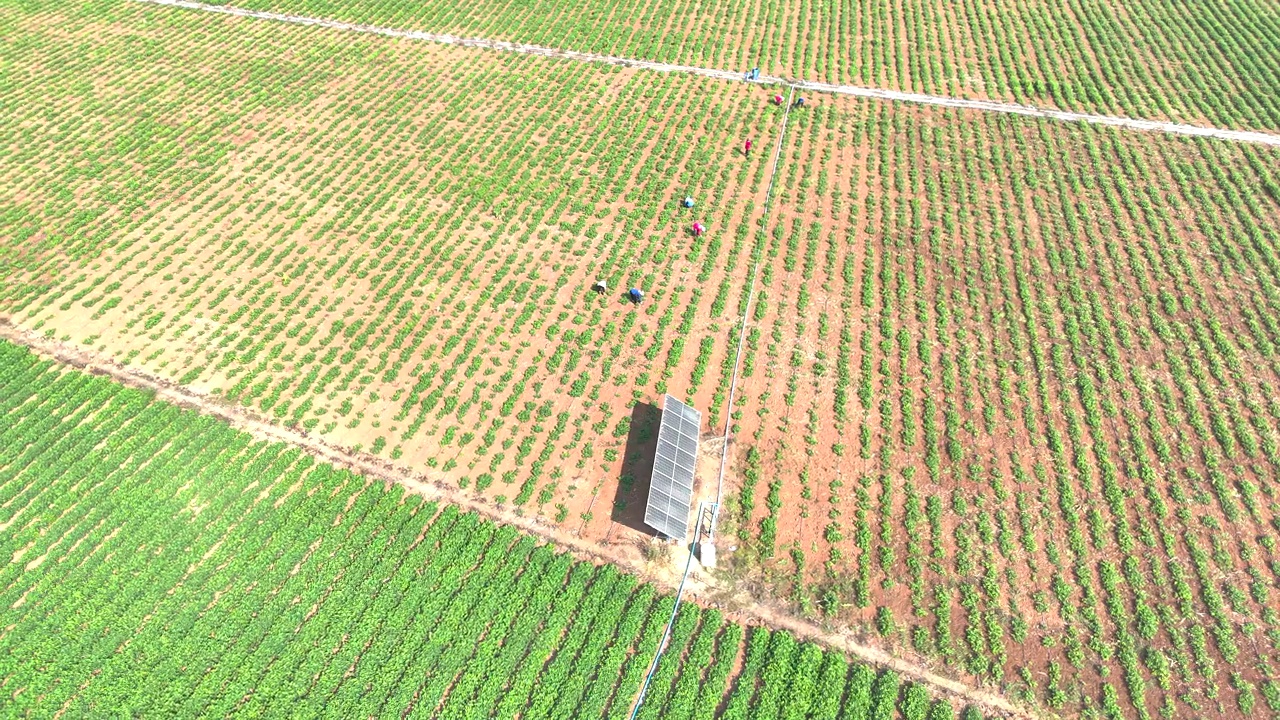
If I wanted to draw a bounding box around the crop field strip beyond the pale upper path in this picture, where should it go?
[214,0,1280,131]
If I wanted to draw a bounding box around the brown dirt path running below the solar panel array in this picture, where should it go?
[0,318,1034,719]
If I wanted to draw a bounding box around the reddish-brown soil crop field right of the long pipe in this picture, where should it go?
[726,88,1280,717]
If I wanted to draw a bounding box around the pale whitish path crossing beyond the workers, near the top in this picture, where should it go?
[134,0,1280,147]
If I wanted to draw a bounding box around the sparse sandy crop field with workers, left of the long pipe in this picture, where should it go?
[0,3,781,536]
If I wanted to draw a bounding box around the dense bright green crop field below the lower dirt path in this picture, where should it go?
[0,341,980,720]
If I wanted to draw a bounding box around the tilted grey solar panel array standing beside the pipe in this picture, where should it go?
[644,395,703,539]
